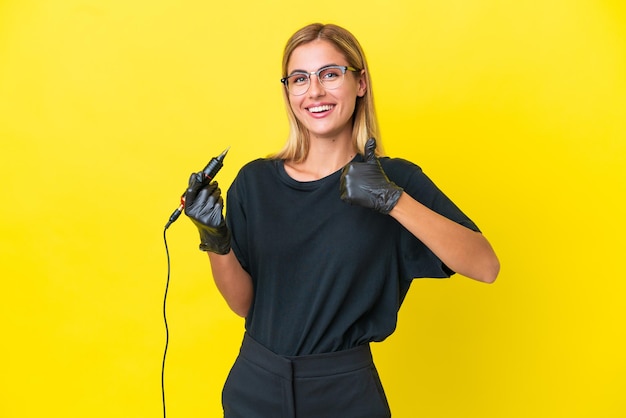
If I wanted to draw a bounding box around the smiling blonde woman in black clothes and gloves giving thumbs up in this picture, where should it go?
[185,24,499,418]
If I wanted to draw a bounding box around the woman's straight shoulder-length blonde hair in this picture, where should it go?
[270,23,382,163]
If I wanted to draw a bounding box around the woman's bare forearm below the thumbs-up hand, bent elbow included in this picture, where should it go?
[389,193,500,283]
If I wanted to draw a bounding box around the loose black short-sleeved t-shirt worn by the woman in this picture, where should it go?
[226,155,478,356]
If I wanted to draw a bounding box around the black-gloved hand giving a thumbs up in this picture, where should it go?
[340,138,402,215]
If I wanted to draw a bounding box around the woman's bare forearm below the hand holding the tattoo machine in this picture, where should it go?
[208,250,254,318]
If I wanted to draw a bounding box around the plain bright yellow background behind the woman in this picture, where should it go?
[0,0,626,418]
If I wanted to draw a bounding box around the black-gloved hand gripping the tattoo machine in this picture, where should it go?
[185,173,230,254]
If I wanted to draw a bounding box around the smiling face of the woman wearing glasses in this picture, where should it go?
[287,40,367,143]
